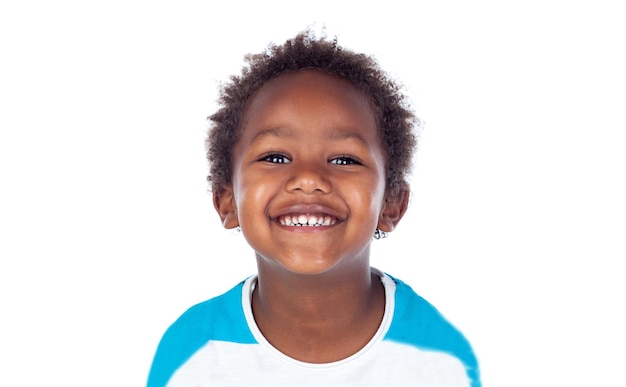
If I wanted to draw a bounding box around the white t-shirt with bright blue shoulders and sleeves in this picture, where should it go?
[148,269,481,387]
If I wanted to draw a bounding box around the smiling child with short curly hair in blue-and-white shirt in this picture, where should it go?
[148,32,480,387]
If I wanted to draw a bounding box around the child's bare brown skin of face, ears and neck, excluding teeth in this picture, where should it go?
[214,70,408,363]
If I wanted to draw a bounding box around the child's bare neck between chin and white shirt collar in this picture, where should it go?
[252,263,385,363]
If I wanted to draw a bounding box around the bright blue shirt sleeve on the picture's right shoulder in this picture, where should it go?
[385,276,480,386]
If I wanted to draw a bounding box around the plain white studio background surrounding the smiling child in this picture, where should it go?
[0,0,626,387]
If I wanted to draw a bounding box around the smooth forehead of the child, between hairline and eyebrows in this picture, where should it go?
[242,70,377,136]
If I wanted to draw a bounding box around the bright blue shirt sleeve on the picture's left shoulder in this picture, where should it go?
[148,282,256,386]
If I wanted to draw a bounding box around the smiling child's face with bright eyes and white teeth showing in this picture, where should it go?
[215,70,395,274]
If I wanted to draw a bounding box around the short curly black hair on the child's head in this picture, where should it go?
[206,30,419,202]
